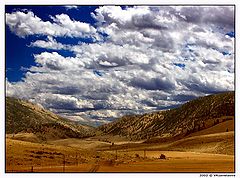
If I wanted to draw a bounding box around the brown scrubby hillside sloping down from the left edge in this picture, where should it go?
[6,97,95,141]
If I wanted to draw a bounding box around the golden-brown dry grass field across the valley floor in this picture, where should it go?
[6,120,235,172]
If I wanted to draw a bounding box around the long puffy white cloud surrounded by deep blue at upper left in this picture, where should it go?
[6,11,98,39]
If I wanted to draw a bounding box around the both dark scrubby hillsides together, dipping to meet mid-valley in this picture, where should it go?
[6,92,235,140]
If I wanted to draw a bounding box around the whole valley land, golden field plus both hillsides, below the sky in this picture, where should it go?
[6,93,235,173]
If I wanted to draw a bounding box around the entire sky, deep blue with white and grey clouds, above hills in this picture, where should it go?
[5,5,235,125]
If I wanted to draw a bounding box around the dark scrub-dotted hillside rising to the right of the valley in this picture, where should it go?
[98,92,235,140]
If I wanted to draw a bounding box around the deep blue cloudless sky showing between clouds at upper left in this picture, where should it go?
[5,6,97,82]
